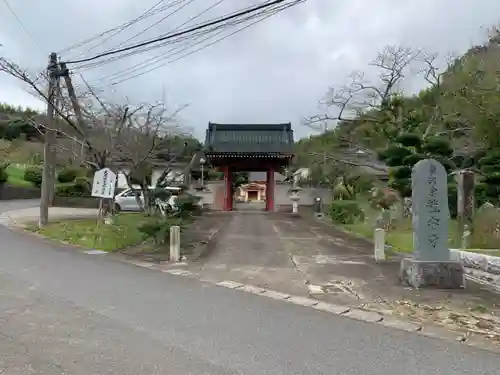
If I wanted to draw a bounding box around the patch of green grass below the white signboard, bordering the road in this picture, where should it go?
[27,213,151,251]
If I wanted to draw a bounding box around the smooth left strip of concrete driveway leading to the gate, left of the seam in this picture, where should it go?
[189,211,308,295]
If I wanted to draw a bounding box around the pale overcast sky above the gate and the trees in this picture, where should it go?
[0,0,500,137]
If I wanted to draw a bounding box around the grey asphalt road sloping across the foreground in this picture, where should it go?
[0,201,500,375]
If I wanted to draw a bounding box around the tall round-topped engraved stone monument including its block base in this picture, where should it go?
[399,159,465,289]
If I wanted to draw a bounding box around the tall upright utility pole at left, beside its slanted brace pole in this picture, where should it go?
[38,53,59,228]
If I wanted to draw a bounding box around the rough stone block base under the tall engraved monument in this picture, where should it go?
[399,258,465,289]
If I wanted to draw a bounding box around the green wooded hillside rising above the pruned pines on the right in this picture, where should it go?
[296,33,500,172]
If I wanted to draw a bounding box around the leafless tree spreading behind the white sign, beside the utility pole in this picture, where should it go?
[0,59,192,214]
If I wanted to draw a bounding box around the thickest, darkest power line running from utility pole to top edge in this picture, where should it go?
[66,0,285,64]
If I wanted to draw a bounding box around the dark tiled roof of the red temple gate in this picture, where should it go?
[205,122,293,154]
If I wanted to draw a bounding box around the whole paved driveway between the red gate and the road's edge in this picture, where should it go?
[190,211,394,305]
